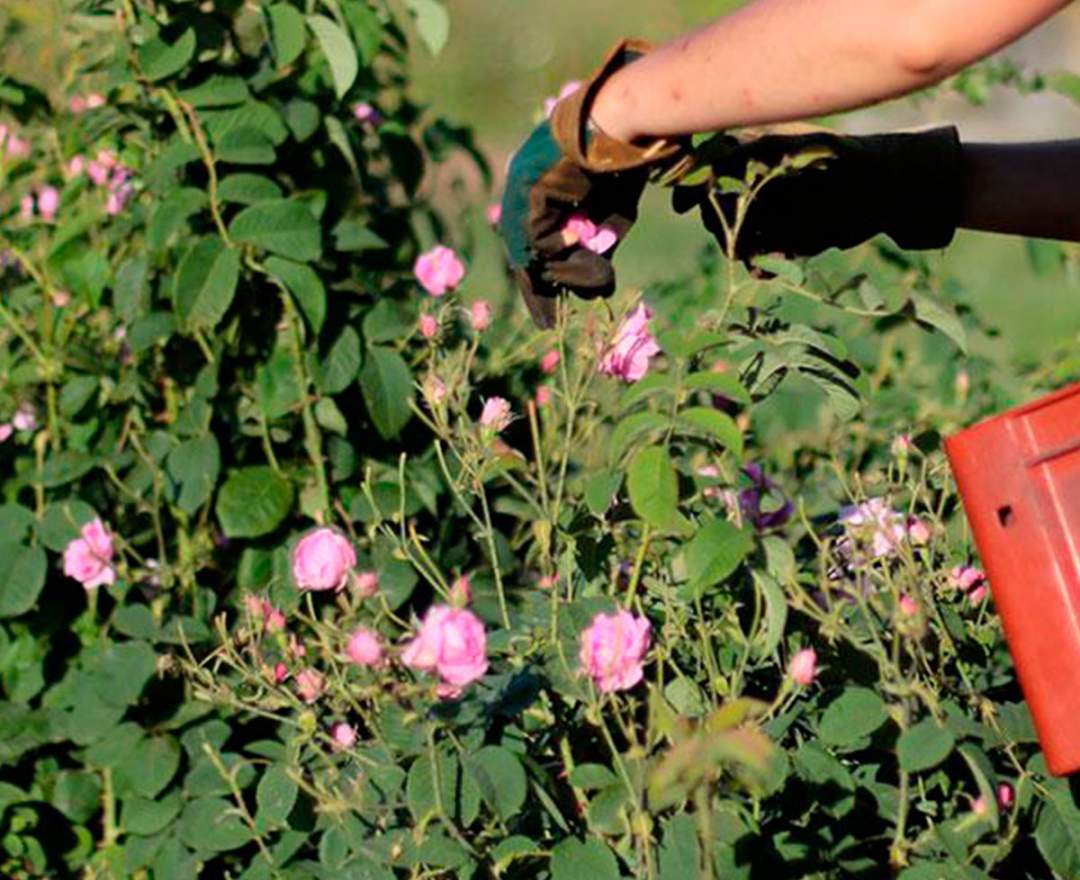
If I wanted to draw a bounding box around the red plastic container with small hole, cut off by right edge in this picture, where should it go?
[945,384,1080,776]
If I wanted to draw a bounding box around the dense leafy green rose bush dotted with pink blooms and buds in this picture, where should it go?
[0,0,1080,880]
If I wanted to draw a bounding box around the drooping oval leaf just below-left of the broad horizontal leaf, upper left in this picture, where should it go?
[173,238,240,331]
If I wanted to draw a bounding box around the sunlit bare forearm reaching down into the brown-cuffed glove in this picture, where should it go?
[592,0,1068,140]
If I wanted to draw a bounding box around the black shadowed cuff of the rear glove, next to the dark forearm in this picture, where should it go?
[879,125,963,251]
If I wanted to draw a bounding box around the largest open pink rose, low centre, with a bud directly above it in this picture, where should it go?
[402,605,488,695]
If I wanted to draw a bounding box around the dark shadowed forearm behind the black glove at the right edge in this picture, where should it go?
[960,140,1080,242]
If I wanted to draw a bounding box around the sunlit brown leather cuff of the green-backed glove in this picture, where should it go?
[551,39,686,173]
